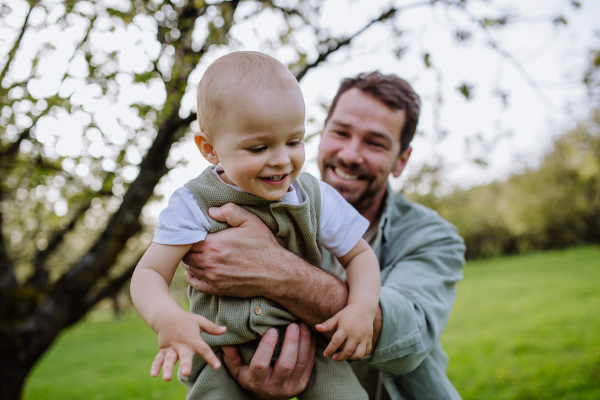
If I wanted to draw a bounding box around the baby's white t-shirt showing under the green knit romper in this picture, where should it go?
[154,166,369,257]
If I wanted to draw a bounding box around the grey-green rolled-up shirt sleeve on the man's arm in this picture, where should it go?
[363,203,465,374]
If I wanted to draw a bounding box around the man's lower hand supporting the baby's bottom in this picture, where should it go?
[223,323,316,400]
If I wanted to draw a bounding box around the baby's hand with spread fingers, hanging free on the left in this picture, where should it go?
[150,310,227,381]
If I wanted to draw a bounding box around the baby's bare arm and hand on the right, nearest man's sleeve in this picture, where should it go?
[316,239,381,361]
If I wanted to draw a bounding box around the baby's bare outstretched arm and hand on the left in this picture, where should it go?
[131,243,225,381]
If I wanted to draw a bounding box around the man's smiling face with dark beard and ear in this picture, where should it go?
[318,88,411,211]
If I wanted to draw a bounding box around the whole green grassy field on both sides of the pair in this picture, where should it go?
[25,247,600,400]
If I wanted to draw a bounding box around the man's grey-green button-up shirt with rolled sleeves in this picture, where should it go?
[323,189,465,400]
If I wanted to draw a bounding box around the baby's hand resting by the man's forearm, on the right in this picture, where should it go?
[316,304,375,361]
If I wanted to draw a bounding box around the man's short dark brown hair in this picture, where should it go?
[325,71,421,152]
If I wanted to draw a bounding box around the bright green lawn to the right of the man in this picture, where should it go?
[442,247,600,400]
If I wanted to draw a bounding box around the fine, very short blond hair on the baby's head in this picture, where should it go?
[197,51,300,135]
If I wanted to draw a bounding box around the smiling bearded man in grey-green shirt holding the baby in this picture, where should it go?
[184,72,465,400]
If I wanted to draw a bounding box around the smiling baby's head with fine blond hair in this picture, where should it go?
[194,51,304,200]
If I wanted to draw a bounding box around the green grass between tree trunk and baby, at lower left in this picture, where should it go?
[25,313,186,400]
